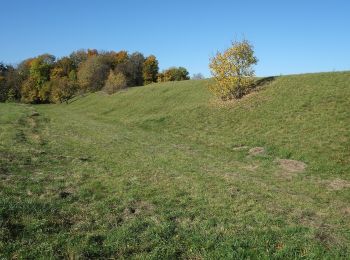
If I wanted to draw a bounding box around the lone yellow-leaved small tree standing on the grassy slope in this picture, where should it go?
[209,40,258,100]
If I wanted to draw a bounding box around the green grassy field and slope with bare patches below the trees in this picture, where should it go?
[0,72,350,259]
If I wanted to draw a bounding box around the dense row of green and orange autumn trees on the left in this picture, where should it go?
[0,49,190,104]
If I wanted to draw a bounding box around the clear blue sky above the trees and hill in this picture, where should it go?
[0,0,350,76]
